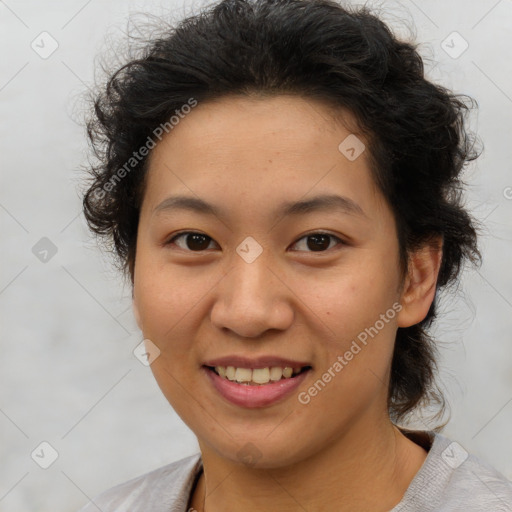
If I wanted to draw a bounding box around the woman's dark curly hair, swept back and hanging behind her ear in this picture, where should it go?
[83,0,481,421]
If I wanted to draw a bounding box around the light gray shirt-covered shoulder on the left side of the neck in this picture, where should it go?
[79,454,202,512]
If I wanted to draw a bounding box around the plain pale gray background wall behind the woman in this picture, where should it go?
[0,0,512,512]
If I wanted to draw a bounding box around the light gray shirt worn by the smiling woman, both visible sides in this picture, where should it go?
[79,431,512,512]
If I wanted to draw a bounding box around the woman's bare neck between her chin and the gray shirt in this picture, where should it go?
[190,420,427,512]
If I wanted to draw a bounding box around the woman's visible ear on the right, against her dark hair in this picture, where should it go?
[397,236,443,327]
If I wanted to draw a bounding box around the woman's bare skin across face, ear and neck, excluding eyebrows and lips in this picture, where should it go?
[133,95,441,512]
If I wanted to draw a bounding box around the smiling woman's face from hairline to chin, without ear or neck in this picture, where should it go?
[133,96,416,467]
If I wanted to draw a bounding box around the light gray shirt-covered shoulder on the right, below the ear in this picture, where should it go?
[393,432,512,512]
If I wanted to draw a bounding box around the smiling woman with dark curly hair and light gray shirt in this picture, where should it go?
[77,0,512,512]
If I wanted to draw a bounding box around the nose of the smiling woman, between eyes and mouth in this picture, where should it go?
[210,251,294,338]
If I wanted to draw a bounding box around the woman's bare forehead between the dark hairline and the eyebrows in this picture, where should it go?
[140,96,384,218]
